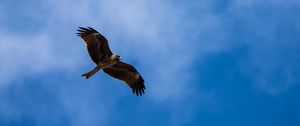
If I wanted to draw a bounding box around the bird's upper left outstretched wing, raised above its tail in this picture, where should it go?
[77,27,112,64]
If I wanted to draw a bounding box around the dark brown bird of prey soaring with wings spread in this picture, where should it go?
[77,27,145,96]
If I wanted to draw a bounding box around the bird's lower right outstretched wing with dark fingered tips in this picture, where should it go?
[103,61,145,96]
